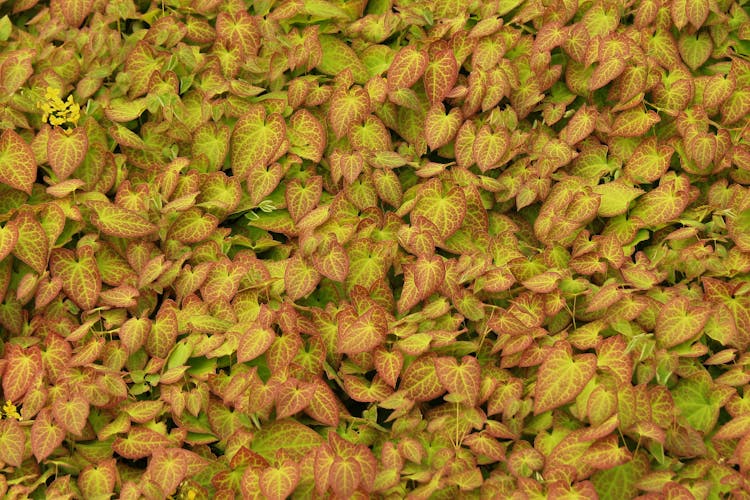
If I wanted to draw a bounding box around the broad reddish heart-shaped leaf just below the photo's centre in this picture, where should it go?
[336,307,388,355]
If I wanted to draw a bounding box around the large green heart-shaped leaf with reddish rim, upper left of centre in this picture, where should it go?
[230,104,286,180]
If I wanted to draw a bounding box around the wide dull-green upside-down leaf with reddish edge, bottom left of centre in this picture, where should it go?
[250,419,323,462]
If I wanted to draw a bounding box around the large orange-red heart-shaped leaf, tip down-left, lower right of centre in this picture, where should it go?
[534,346,596,415]
